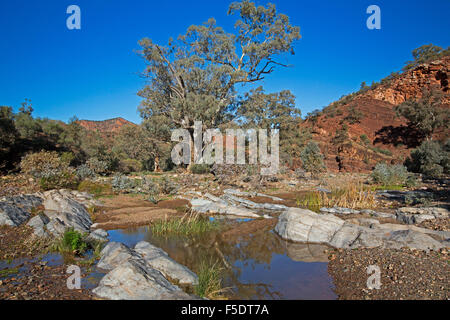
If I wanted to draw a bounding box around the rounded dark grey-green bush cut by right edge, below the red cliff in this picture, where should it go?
[405,140,450,178]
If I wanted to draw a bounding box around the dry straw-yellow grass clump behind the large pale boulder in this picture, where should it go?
[297,184,377,211]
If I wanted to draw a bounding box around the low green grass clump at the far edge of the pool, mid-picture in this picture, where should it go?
[151,213,220,236]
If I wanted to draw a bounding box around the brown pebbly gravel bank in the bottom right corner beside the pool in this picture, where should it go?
[328,248,450,300]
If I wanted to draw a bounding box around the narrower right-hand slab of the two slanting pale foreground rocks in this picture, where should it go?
[134,241,198,285]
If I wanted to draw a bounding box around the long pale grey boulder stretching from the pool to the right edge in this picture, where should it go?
[275,208,448,250]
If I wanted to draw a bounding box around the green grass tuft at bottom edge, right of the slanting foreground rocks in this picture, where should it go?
[194,260,225,299]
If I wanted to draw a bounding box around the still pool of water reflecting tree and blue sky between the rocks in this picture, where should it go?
[110,221,336,299]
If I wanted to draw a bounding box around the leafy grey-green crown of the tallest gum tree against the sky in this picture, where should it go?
[138,1,300,154]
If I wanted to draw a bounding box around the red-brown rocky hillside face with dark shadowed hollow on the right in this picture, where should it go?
[304,57,450,172]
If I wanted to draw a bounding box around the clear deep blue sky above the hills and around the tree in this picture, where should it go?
[0,0,450,122]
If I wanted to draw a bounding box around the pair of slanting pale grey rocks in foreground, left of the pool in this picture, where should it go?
[93,241,198,300]
